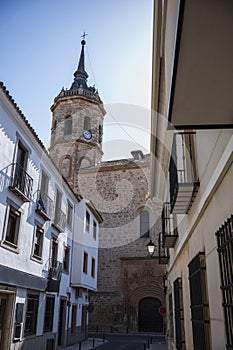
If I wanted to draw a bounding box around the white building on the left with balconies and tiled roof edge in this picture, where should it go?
[0,83,100,350]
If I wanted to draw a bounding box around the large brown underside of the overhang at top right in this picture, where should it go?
[165,0,233,130]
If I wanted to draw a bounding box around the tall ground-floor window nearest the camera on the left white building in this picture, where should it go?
[24,294,39,336]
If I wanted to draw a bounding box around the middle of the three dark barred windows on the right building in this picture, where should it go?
[188,252,210,350]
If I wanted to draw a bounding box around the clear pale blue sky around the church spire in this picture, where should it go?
[0,0,152,159]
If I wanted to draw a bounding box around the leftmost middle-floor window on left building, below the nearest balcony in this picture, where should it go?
[5,206,21,246]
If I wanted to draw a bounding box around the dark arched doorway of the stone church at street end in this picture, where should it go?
[138,298,163,332]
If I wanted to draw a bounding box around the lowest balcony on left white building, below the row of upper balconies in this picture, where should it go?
[46,258,62,292]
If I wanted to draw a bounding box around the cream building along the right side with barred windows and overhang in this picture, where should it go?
[151,0,233,350]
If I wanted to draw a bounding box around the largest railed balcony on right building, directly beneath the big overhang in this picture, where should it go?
[169,133,200,214]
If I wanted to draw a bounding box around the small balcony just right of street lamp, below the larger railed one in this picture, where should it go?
[162,203,178,248]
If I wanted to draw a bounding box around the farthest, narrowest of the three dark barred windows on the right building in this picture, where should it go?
[174,278,185,350]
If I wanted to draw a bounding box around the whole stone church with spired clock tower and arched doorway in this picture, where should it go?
[49,40,164,332]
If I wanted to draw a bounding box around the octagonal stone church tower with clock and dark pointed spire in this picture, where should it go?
[49,38,106,192]
